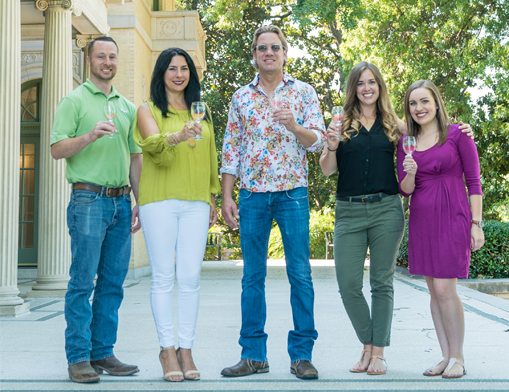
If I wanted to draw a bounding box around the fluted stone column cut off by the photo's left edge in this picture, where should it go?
[0,1,30,315]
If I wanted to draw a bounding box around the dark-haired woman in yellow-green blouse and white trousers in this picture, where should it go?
[134,48,220,381]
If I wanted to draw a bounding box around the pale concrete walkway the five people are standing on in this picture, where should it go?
[0,261,509,391]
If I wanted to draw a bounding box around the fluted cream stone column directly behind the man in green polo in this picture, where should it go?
[28,0,81,297]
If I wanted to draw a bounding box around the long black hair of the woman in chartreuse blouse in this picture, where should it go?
[150,48,212,121]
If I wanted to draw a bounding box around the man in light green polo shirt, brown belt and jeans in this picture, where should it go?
[51,37,142,383]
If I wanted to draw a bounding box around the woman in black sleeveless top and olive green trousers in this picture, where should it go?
[320,61,406,375]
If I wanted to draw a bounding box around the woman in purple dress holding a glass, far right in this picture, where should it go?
[397,80,484,378]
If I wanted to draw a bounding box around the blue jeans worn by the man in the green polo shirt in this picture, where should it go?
[65,190,131,365]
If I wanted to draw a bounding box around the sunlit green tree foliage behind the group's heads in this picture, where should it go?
[179,0,509,219]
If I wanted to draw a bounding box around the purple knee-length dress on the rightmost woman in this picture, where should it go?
[397,124,482,279]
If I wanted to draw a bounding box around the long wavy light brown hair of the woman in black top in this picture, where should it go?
[342,61,401,144]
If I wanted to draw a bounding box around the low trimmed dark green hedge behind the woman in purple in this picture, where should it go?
[397,220,509,279]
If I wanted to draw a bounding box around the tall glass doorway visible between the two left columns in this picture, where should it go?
[18,79,41,266]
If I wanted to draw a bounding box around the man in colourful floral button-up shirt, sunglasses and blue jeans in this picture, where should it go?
[221,26,326,379]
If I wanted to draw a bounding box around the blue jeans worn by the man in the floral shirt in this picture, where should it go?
[239,188,318,362]
